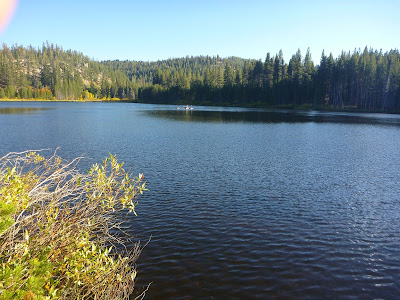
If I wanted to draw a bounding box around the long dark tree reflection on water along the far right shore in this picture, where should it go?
[146,108,400,126]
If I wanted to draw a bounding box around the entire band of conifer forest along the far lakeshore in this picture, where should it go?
[0,43,400,112]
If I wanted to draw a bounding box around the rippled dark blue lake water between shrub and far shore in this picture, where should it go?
[0,102,400,299]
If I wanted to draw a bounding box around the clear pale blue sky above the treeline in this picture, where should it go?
[0,0,400,64]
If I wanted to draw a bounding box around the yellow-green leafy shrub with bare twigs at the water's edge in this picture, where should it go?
[0,152,145,299]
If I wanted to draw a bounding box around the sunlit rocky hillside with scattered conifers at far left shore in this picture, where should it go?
[0,43,138,100]
